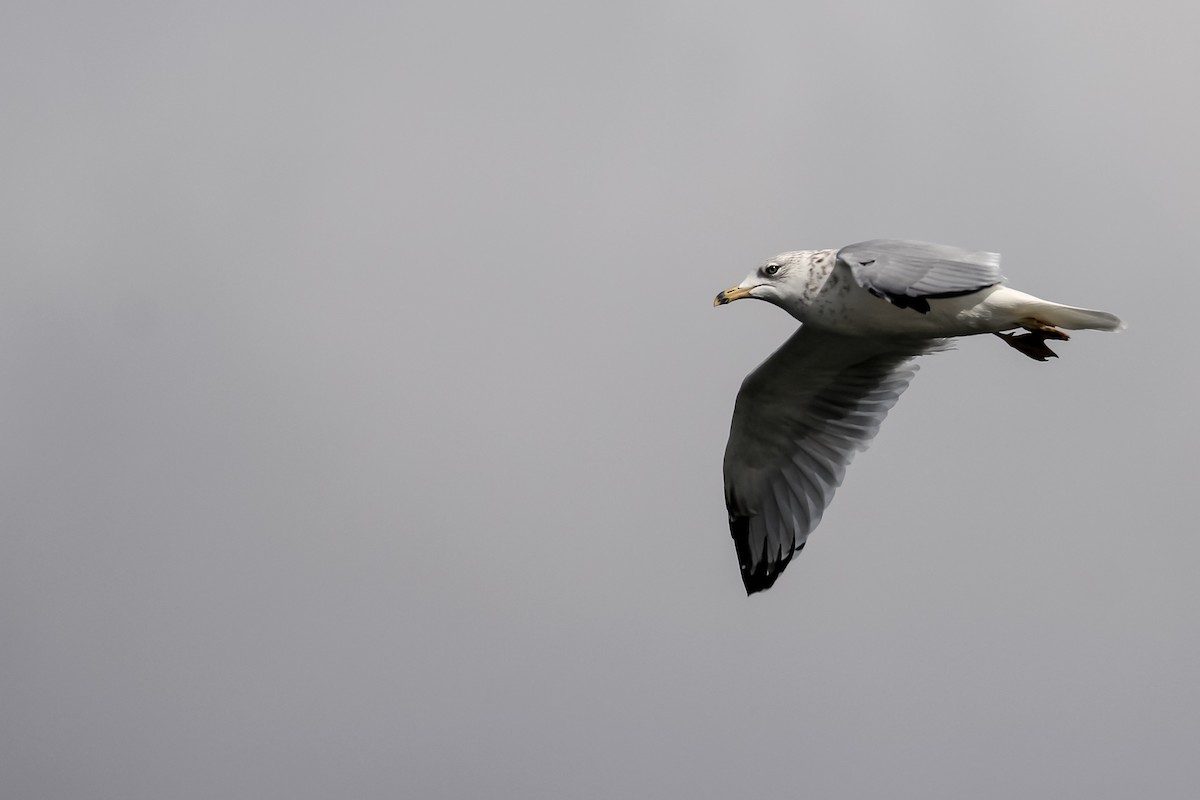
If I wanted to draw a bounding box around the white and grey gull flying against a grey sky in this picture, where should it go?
[713,239,1124,595]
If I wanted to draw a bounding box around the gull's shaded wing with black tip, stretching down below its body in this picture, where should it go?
[725,327,948,595]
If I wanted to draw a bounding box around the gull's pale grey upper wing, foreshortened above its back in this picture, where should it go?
[838,239,1004,314]
